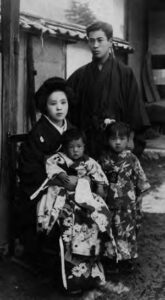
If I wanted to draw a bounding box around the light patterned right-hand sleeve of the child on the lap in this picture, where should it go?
[86,158,109,185]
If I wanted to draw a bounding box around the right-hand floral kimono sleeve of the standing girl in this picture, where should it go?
[132,154,150,196]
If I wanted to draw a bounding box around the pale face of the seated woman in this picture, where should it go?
[46,91,68,126]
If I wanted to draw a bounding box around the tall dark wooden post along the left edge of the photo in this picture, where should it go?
[0,0,20,254]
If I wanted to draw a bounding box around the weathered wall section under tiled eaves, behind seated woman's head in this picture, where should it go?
[16,31,66,134]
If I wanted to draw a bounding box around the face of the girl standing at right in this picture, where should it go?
[108,135,128,153]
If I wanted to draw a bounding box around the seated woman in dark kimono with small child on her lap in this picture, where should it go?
[19,77,72,253]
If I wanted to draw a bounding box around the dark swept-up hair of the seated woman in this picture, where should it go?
[35,77,73,114]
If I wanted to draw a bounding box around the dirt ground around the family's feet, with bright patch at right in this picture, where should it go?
[0,158,165,300]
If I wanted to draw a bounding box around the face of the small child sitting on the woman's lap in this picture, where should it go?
[67,138,85,160]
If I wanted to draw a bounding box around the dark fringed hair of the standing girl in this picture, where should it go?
[105,122,130,139]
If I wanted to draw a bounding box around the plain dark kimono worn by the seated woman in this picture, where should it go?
[15,115,73,248]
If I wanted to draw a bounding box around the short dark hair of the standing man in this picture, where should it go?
[86,21,113,40]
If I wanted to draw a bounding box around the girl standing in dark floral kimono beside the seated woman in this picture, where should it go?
[100,122,150,271]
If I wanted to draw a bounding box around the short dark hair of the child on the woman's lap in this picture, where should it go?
[62,128,86,150]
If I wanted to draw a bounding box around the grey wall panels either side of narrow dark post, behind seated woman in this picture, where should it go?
[16,32,66,133]
